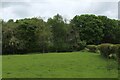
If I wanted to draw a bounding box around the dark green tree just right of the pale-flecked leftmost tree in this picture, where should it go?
[16,22,36,52]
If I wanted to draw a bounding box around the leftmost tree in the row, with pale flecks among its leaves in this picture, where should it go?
[2,20,19,54]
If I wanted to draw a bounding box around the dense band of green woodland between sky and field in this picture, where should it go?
[2,14,120,54]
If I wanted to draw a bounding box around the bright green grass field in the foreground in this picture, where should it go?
[2,52,118,78]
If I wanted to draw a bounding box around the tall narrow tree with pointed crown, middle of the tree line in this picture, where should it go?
[47,14,69,51]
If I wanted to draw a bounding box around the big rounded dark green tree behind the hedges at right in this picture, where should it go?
[71,15,103,44]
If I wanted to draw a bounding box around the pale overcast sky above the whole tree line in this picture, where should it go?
[0,0,118,20]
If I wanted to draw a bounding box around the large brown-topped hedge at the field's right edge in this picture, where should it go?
[98,43,120,60]
